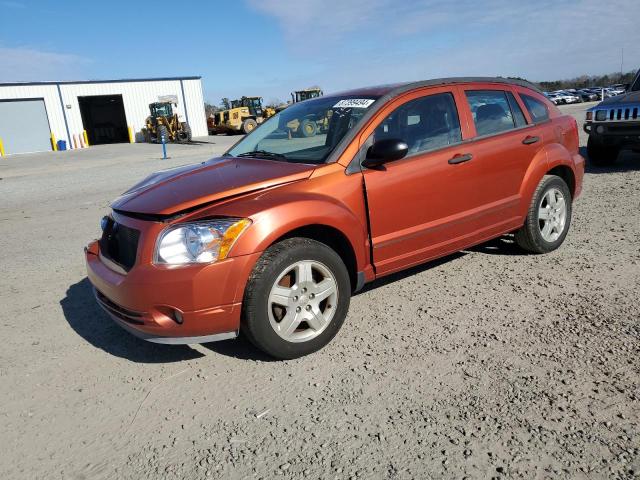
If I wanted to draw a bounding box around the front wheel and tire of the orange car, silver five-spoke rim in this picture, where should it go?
[241,238,351,359]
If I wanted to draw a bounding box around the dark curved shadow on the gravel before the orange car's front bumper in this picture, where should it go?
[60,278,204,363]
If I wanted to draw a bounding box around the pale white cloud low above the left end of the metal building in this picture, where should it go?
[0,45,90,82]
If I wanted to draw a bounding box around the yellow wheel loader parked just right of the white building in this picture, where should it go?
[207,97,276,135]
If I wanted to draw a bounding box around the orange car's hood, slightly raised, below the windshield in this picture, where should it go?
[111,157,315,215]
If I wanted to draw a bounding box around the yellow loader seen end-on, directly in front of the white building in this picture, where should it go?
[142,100,191,143]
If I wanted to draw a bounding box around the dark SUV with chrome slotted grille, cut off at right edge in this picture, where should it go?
[584,70,640,166]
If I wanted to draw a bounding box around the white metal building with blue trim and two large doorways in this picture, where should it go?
[0,77,207,155]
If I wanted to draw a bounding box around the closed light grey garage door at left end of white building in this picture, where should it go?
[0,98,51,155]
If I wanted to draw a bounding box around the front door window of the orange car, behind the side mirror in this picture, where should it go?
[373,93,462,155]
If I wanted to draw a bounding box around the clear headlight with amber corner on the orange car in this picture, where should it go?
[154,218,251,265]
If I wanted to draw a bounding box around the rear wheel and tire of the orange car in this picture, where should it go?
[515,175,571,253]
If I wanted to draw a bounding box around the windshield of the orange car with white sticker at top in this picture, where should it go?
[227,96,378,164]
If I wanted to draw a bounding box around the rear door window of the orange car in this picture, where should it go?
[466,90,522,136]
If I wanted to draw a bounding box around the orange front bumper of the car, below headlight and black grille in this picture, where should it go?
[85,214,259,344]
